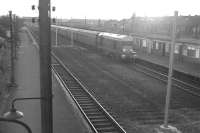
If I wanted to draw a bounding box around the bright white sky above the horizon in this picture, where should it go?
[0,0,200,19]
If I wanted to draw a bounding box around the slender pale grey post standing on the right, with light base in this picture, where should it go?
[164,11,178,128]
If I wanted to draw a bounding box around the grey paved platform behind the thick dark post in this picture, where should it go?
[0,28,88,133]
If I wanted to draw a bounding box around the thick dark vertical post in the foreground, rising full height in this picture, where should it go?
[39,0,53,133]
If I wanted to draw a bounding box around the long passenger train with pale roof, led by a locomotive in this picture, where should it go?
[52,25,137,61]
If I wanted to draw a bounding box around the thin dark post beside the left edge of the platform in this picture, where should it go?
[9,11,15,87]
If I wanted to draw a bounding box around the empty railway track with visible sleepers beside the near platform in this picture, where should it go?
[52,55,125,133]
